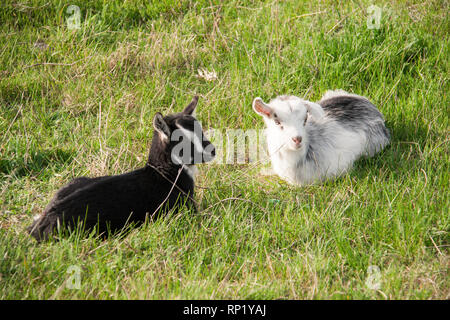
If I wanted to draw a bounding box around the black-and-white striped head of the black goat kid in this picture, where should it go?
[153,96,216,165]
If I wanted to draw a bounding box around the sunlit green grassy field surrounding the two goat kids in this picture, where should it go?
[0,0,450,299]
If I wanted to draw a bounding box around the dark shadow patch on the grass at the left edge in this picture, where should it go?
[0,149,75,177]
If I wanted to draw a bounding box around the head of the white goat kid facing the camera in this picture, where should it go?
[253,96,324,152]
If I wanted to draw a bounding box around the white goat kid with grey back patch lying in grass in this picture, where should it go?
[253,90,389,185]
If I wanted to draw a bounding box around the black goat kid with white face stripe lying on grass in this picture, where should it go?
[28,97,215,241]
